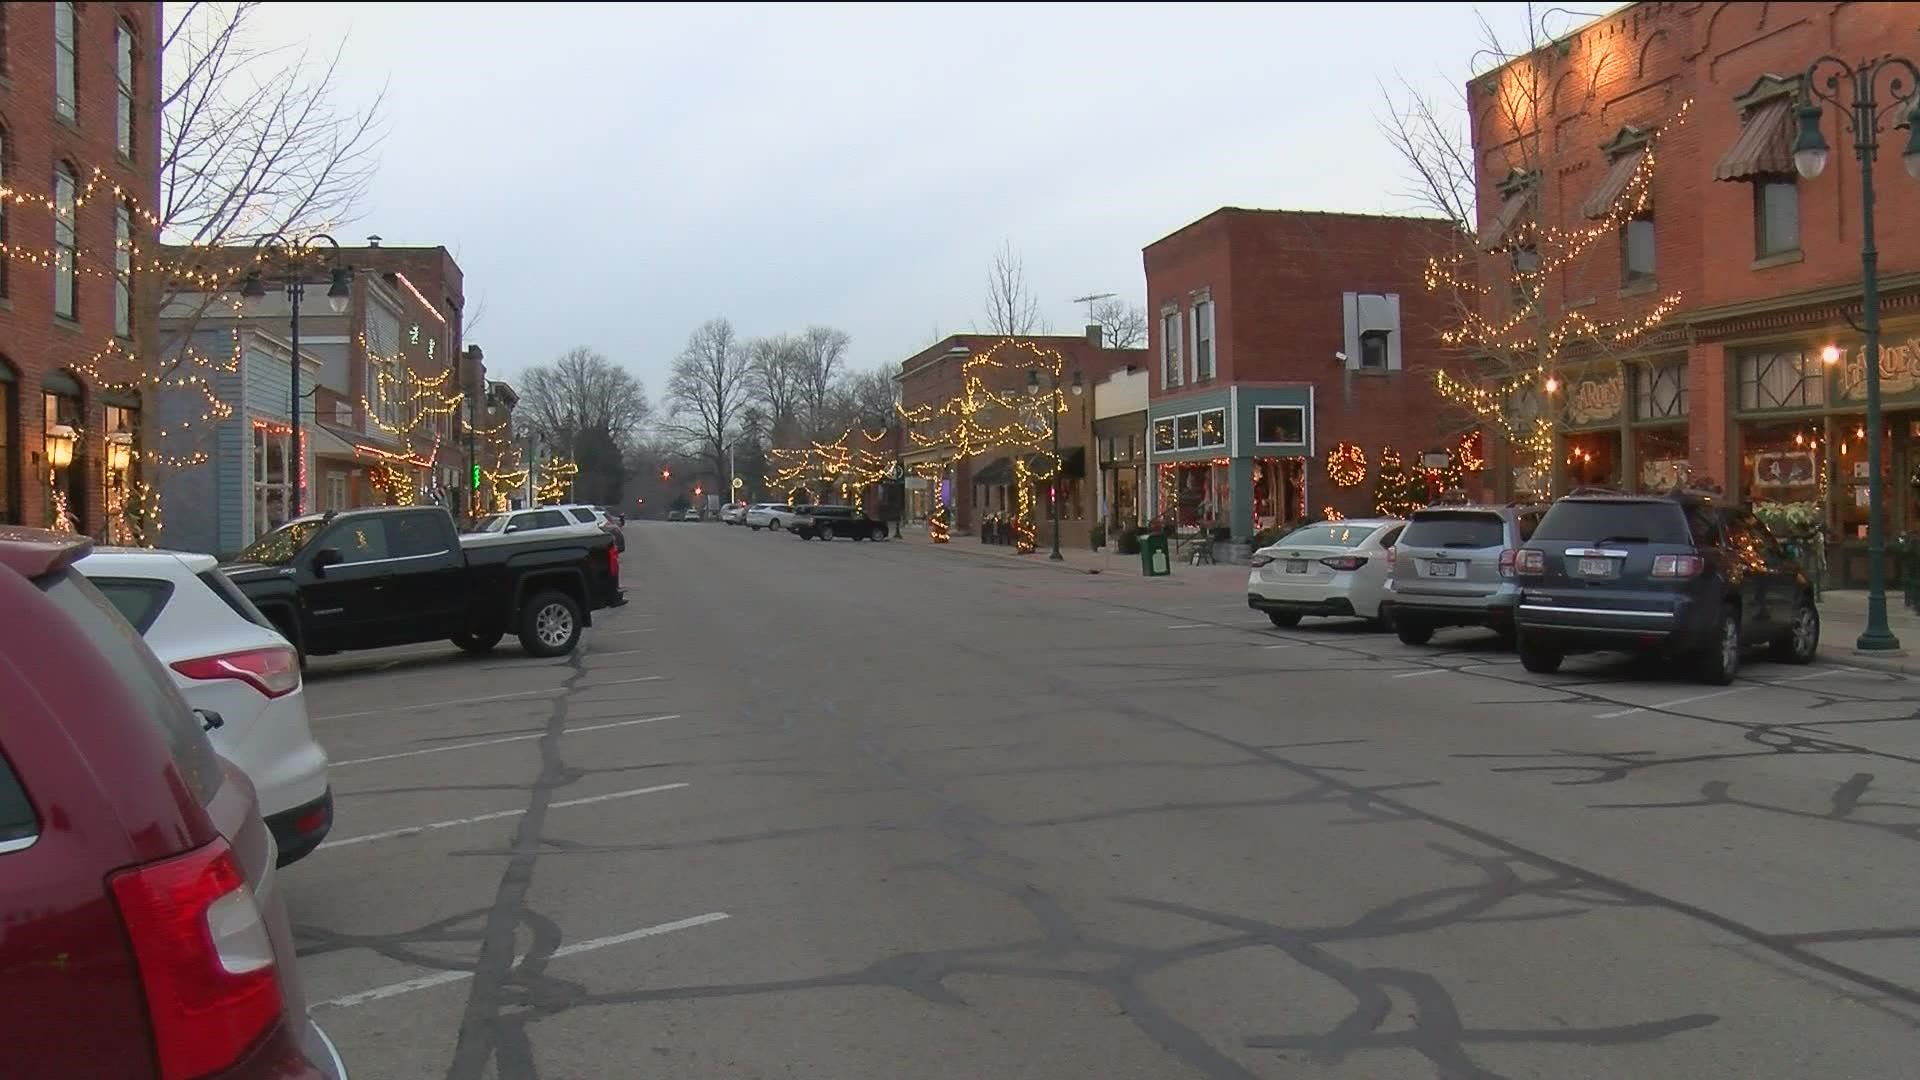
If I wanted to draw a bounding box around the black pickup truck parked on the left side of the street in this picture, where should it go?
[221,507,626,657]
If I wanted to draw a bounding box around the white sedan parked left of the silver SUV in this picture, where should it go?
[1246,517,1405,626]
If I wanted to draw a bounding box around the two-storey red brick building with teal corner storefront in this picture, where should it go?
[1142,208,1463,538]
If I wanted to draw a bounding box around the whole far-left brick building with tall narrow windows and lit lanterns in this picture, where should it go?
[0,2,159,536]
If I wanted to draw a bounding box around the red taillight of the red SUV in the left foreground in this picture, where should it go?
[108,840,282,1080]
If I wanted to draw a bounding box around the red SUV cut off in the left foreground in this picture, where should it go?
[0,527,346,1080]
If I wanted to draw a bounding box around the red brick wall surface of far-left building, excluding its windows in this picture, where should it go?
[0,4,159,532]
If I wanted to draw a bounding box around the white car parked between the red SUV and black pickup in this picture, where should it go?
[75,548,334,867]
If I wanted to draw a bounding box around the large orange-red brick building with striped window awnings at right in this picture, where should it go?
[1467,4,1920,580]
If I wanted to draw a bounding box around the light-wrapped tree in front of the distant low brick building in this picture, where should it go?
[900,336,1066,553]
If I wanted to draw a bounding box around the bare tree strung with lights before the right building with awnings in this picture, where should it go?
[1380,8,1692,486]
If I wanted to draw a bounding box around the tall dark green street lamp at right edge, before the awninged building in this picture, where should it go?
[1793,56,1920,651]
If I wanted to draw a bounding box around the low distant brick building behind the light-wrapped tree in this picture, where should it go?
[899,327,1146,546]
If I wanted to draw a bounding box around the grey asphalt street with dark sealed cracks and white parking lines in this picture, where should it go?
[288,523,1920,1080]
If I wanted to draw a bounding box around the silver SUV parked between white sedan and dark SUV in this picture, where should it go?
[1384,505,1548,646]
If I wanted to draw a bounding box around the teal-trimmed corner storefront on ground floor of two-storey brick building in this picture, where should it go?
[1146,384,1313,540]
